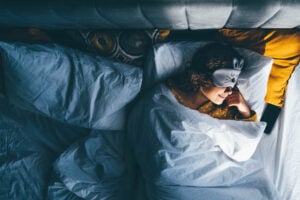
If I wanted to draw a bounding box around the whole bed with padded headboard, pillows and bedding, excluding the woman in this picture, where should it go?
[0,0,300,200]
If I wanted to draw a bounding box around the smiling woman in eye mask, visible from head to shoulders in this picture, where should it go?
[167,43,257,121]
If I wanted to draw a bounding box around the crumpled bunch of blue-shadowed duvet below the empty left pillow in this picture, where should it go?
[51,131,134,200]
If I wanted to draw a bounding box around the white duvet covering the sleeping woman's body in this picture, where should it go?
[127,84,277,200]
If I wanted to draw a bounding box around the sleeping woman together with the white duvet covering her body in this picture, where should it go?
[127,43,277,200]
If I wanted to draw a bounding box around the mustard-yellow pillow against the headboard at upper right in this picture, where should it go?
[219,29,300,107]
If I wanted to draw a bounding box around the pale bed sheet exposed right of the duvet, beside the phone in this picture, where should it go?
[254,64,300,200]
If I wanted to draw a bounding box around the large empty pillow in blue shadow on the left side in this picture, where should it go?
[0,42,142,130]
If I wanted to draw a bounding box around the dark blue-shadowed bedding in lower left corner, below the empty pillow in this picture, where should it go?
[0,95,88,200]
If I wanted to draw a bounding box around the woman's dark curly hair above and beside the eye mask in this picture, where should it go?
[168,43,242,94]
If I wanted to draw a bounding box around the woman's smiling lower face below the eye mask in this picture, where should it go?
[200,86,232,105]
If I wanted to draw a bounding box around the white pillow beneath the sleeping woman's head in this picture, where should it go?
[142,42,273,118]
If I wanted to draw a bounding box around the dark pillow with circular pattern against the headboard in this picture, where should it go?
[69,29,170,66]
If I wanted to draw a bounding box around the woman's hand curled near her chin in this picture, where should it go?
[226,91,251,118]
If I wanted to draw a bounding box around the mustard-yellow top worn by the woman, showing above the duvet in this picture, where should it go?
[171,88,257,121]
